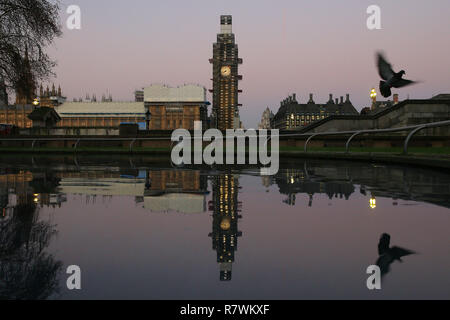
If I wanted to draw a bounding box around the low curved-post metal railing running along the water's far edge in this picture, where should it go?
[0,120,450,154]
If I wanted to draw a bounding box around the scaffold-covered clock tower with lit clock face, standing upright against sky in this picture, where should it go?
[209,16,242,130]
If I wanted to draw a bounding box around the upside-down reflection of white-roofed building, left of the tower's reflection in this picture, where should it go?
[55,169,208,213]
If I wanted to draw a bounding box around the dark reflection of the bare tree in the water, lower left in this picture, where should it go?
[0,204,62,300]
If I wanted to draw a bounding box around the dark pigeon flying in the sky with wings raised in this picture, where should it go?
[377,53,415,98]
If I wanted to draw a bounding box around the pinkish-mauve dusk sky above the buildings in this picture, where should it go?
[50,0,450,128]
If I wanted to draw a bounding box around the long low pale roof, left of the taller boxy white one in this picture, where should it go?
[55,102,145,118]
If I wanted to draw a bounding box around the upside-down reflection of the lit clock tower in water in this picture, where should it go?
[209,174,242,281]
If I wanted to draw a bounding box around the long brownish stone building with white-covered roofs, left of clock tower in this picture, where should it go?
[0,85,209,130]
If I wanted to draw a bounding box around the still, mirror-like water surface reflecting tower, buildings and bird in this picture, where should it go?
[0,155,450,299]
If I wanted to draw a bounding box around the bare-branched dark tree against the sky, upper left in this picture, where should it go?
[0,0,61,98]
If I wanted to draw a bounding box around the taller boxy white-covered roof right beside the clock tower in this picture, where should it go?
[144,84,206,102]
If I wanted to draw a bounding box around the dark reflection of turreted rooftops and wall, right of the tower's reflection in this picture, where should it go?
[268,161,450,209]
